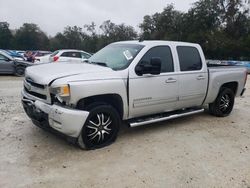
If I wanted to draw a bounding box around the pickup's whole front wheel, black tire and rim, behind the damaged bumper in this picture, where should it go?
[78,104,121,149]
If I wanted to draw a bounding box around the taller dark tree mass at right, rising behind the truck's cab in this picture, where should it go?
[140,0,250,59]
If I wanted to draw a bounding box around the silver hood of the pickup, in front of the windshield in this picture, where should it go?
[25,63,113,85]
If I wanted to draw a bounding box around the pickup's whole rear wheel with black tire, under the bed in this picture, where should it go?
[209,88,235,117]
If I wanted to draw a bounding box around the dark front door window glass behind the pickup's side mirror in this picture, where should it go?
[140,46,174,73]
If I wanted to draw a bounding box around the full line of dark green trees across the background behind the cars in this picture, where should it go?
[0,0,250,60]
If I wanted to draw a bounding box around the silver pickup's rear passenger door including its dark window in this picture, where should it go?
[177,46,208,108]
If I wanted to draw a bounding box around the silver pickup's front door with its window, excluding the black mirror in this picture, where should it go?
[129,46,178,118]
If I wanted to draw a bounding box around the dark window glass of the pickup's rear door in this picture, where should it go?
[177,46,202,71]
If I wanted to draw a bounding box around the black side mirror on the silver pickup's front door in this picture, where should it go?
[135,57,161,76]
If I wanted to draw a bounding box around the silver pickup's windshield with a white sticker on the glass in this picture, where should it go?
[89,44,144,70]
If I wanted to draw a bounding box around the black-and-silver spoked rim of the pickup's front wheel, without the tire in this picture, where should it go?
[86,113,113,145]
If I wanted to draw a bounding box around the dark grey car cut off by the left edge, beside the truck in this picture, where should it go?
[0,51,32,76]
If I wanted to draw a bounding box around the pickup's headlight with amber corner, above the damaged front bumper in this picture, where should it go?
[50,85,70,103]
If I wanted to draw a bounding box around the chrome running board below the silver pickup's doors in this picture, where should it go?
[129,109,204,127]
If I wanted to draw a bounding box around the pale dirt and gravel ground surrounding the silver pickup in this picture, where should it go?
[0,76,250,188]
